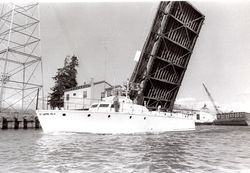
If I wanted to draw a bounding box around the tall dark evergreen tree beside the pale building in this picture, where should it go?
[48,55,79,108]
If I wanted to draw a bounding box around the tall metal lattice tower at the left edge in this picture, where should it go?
[0,3,43,113]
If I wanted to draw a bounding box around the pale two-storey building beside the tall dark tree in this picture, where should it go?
[64,79,112,110]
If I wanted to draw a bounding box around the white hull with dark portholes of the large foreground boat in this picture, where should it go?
[37,110,195,134]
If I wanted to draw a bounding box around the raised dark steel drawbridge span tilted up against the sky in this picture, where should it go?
[130,1,205,111]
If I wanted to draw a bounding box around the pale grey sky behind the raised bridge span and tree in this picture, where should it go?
[40,1,250,112]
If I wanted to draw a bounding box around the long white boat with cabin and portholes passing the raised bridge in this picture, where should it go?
[36,96,195,134]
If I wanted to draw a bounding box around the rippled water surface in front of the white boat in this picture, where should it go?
[0,126,250,173]
